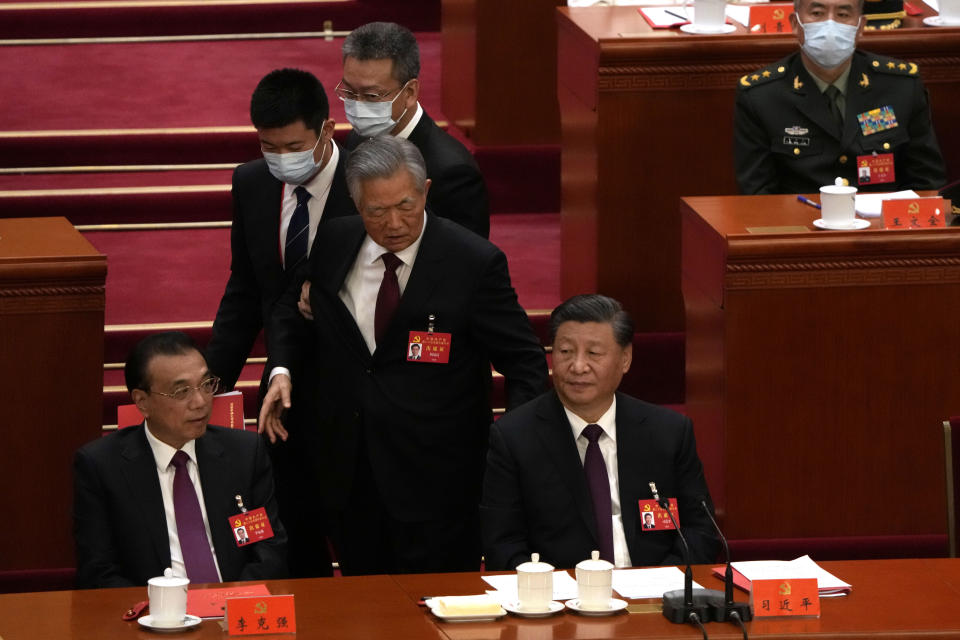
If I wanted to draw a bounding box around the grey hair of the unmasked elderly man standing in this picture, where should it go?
[346,136,427,202]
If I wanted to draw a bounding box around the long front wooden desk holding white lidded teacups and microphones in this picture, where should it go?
[0,559,960,640]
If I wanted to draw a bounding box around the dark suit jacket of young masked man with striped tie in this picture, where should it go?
[205,149,357,389]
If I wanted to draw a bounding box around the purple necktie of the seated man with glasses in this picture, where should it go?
[170,451,220,584]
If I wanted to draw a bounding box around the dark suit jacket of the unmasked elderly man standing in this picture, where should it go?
[269,215,547,522]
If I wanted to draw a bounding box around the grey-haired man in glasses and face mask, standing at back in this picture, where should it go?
[336,22,490,238]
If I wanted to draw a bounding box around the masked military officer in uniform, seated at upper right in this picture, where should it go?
[734,0,946,194]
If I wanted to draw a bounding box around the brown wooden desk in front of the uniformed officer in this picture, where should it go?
[680,196,960,538]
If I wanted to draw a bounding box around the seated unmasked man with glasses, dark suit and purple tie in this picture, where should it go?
[73,331,286,588]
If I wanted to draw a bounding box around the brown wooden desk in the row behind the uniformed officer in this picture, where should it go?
[557,3,960,331]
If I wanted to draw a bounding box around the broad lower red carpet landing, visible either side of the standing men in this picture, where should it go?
[84,213,560,325]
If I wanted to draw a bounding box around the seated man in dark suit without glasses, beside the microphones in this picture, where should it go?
[480,295,719,570]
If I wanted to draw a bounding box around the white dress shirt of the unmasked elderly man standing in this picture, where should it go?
[340,212,427,354]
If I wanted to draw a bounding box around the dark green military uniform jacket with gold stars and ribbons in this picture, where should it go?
[734,51,946,194]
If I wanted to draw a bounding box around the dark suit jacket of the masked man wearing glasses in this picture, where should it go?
[346,111,490,238]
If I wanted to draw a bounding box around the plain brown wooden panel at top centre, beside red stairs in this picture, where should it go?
[441,0,566,146]
